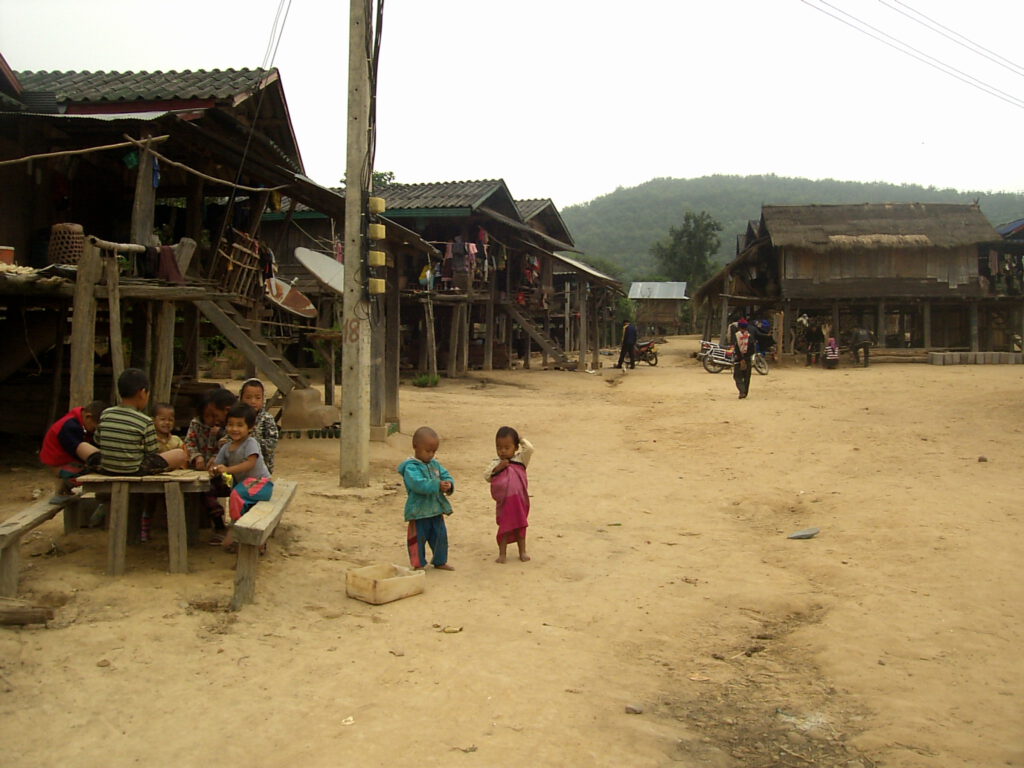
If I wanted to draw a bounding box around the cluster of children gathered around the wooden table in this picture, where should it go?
[39,368,281,548]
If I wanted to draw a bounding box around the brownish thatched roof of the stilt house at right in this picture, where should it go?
[761,203,999,253]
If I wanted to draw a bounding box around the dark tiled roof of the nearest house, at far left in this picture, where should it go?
[16,70,276,103]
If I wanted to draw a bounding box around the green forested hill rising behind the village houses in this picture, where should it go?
[561,176,1024,281]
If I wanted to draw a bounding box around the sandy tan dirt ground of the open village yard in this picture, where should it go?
[0,338,1024,768]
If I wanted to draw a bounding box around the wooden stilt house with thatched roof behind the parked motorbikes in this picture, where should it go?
[694,203,1003,357]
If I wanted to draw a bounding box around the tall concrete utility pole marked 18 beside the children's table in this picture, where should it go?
[340,0,372,487]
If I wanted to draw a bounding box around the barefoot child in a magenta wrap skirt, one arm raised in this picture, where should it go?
[485,427,534,562]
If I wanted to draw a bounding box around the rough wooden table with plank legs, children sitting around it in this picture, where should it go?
[77,469,210,575]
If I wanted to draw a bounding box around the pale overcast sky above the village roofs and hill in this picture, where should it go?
[0,0,1024,207]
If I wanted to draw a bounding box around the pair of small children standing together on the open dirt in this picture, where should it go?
[398,427,534,570]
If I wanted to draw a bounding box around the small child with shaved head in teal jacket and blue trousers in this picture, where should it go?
[398,427,455,570]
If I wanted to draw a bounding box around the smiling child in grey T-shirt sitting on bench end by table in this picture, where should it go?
[210,402,273,549]
